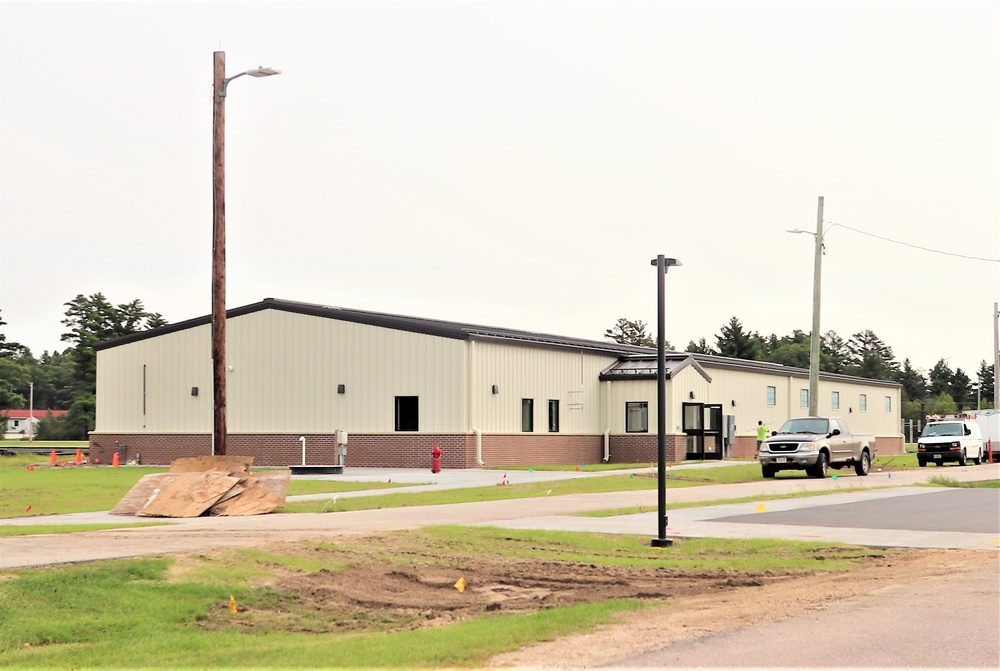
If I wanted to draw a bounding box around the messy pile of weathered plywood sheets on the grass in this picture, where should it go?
[111,455,292,517]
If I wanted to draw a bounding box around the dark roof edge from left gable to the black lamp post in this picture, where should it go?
[94,298,655,356]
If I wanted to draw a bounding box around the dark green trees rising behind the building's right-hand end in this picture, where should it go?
[604,316,995,419]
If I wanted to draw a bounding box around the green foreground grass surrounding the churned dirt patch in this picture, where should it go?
[0,527,884,669]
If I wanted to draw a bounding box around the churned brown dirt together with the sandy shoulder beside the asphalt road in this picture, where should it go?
[175,535,995,668]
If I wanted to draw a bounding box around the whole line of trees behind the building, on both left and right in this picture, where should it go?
[0,304,994,440]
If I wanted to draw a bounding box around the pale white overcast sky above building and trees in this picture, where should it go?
[0,0,1000,375]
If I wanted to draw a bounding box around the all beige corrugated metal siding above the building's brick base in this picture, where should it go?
[97,310,900,444]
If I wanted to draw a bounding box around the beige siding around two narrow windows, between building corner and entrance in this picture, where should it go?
[469,341,617,434]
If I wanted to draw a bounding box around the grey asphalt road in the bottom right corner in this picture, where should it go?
[613,563,1000,669]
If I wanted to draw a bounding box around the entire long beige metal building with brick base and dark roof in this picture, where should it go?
[90,298,903,468]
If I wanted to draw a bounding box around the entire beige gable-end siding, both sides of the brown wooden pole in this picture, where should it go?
[97,310,468,433]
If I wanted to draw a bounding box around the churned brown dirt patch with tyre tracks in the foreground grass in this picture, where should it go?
[186,536,886,633]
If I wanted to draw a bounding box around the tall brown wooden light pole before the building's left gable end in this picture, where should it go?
[212,51,281,454]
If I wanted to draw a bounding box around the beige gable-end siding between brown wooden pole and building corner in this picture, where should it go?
[227,310,467,433]
